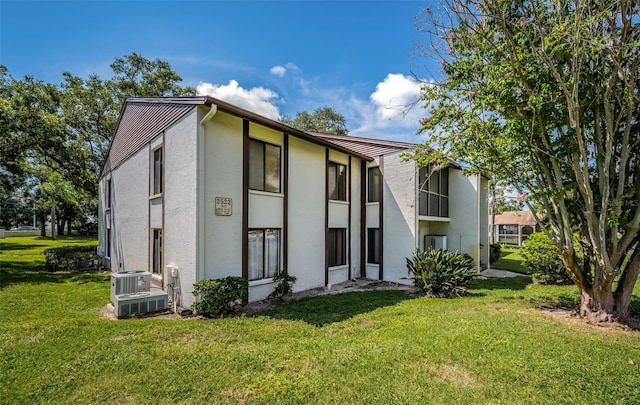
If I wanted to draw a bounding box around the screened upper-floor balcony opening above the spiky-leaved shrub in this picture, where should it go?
[418,165,449,217]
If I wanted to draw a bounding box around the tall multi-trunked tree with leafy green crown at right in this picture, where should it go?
[422,0,640,321]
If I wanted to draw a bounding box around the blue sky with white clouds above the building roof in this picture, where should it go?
[0,0,440,142]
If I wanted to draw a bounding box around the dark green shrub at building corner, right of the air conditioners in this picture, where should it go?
[191,277,249,316]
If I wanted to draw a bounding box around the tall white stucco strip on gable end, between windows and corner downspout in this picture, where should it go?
[162,109,198,306]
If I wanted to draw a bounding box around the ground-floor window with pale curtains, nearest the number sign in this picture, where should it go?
[247,229,280,280]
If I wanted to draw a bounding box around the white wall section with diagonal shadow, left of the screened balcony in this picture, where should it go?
[383,153,417,283]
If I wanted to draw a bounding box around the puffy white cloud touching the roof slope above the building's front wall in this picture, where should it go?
[196,80,282,120]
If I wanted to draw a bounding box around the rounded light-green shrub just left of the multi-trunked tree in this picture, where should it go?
[522,232,571,284]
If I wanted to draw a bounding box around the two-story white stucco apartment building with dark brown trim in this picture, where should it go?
[98,96,489,306]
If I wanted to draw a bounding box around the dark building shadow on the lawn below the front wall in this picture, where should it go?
[251,290,415,327]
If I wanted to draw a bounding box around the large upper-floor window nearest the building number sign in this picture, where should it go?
[249,139,280,193]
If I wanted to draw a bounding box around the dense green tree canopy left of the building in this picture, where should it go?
[0,53,195,230]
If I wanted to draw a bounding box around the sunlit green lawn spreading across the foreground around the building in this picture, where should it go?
[0,238,640,404]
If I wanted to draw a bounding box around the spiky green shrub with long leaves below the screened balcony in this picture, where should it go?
[407,249,477,297]
